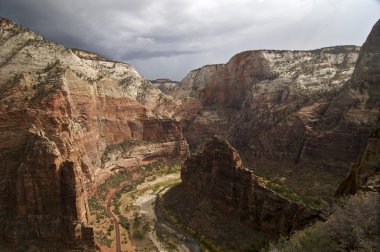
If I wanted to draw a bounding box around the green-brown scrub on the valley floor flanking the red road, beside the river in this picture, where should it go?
[88,160,184,247]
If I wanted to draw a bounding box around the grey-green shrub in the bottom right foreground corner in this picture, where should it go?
[269,193,379,252]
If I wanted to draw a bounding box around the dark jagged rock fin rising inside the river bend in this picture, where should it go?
[181,137,319,234]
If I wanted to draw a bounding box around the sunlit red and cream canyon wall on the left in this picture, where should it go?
[0,19,188,250]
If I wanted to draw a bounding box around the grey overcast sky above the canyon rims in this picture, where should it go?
[0,0,380,81]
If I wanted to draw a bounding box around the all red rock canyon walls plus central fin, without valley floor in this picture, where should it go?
[0,14,380,251]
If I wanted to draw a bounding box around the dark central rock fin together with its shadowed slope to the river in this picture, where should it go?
[164,137,321,251]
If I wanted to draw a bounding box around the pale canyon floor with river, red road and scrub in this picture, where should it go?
[89,162,200,252]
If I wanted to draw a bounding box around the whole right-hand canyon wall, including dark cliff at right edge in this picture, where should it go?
[172,18,380,179]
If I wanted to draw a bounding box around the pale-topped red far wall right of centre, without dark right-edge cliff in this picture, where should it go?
[172,46,359,161]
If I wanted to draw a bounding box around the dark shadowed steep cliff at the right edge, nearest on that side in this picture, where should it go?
[301,20,380,171]
